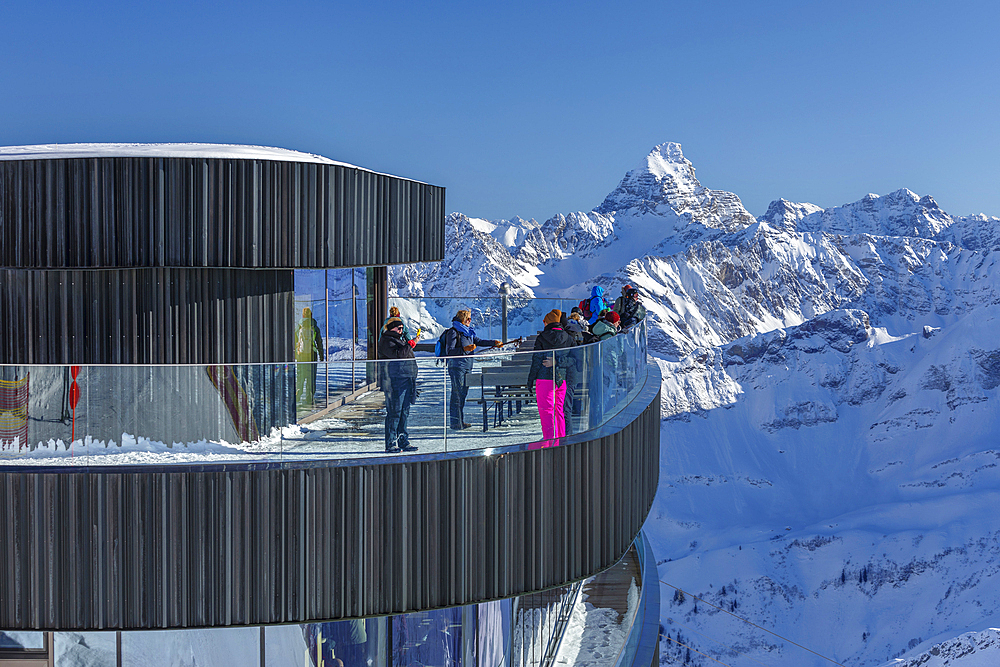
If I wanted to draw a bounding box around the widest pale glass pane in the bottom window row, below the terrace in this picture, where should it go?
[122,628,260,667]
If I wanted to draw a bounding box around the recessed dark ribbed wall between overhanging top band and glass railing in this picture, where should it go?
[0,268,295,364]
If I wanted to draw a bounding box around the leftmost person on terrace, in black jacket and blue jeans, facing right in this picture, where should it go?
[378,317,417,454]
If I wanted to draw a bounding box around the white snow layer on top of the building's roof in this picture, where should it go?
[0,144,424,180]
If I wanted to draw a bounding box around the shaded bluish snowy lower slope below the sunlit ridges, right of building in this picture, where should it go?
[646,306,1000,665]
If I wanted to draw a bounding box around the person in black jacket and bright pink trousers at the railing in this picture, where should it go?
[528,310,576,440]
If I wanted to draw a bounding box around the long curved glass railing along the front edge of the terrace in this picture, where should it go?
[0,322,646,466]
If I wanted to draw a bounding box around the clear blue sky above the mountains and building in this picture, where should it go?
[0,0,1000,220]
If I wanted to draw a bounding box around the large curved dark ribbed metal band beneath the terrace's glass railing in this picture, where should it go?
[0,366,660,630]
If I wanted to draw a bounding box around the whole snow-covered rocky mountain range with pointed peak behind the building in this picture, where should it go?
[392,143,1000,666]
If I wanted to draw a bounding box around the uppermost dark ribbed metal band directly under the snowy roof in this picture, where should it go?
[0,157,445,269]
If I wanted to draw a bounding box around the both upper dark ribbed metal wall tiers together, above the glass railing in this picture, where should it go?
[0,149,444,364]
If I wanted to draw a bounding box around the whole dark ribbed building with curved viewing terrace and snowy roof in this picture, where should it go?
[0,145,659,665]
